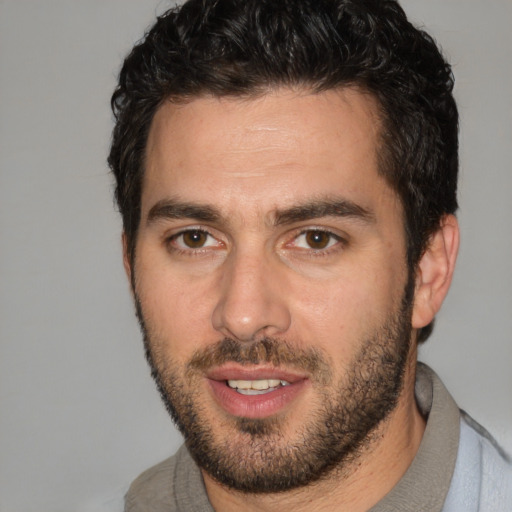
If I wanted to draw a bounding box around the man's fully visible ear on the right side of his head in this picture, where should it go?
[412,215,459,329]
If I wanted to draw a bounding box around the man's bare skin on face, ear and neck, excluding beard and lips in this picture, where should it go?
[125,88,458,512]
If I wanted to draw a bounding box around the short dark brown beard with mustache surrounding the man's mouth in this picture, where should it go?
[136,283,412,493]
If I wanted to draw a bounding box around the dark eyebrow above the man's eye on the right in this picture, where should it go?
[274,199,375,225]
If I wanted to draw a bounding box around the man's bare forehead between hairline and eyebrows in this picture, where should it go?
[142,88,391,220]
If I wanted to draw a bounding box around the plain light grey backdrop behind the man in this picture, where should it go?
[0,0,512,512]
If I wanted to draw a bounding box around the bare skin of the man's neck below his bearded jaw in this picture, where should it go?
[203,350,425,512]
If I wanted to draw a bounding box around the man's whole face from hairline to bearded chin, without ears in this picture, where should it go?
[132,89,410,492]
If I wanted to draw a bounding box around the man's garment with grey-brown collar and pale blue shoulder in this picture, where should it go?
[125,363,512,512]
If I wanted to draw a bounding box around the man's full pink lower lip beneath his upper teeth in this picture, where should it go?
[208,379,307,418]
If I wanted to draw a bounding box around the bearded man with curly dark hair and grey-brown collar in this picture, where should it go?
[109,0,512,512]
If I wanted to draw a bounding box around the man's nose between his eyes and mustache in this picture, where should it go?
[212,248,291,341]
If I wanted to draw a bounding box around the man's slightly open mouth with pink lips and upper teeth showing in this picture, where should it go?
[206,366,309,418]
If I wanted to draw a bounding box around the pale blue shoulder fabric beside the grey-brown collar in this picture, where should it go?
[443,411,512,512]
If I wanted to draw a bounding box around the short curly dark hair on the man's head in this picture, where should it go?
[108,0,458,341]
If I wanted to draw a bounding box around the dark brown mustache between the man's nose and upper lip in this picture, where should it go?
[187,337,332,381]
